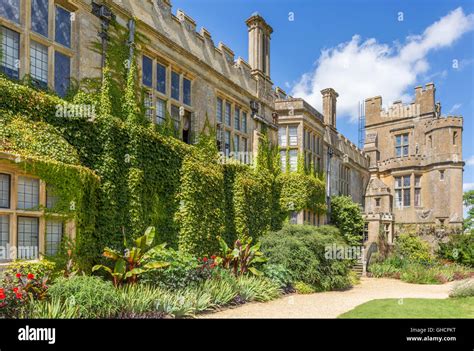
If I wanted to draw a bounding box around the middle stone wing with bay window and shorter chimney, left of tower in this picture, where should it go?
[275,88,369,225]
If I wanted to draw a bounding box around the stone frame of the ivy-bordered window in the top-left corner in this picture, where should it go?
[0,0,79,95]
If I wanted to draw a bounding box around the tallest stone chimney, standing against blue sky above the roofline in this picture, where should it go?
[245,12,273,78]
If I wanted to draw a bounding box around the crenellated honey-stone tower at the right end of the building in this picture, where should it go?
[364,83,464,242]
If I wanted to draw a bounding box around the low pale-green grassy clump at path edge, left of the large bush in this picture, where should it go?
[237,276,281,302]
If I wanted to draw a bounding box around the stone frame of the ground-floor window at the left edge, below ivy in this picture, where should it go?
[0,159,76,266]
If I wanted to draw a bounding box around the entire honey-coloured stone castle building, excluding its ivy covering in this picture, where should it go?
[0,0,464,262]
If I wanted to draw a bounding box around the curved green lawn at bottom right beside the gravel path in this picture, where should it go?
[338,297,474,318]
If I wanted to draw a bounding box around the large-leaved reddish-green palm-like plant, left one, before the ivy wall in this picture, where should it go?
[92,227,169,286]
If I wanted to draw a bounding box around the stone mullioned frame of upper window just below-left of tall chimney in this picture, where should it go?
[215,90,251,163]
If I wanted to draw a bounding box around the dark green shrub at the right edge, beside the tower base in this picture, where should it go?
[437,233,474,267]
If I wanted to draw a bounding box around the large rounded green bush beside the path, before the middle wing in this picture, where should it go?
[261,225,352,290]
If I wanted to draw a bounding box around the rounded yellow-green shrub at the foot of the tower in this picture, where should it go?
[394,234,433,263]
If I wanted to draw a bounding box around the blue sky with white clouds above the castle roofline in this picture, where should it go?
[172,0,474,190]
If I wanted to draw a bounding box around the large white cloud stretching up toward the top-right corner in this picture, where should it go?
[292,7,474,121]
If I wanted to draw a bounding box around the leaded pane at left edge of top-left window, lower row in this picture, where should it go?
[0,27,20,79]
